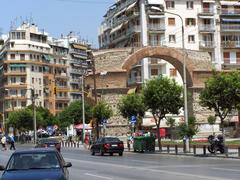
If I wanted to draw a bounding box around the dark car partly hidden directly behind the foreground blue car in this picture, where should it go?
[35,138,61,152]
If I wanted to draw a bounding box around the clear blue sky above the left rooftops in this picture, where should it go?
[0,0,115,47]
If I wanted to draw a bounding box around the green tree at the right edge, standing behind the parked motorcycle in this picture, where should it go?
[200,72,240,133]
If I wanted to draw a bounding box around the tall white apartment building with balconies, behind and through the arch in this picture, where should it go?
[98,0,240,85]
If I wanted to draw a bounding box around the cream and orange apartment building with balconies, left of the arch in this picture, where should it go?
[0,23,89,122]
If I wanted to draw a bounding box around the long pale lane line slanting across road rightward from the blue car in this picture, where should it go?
[65,158,233,180]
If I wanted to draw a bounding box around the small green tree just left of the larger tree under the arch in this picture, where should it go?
[118,93,145,131]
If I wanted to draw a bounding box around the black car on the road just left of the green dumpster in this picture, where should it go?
[91,137,124,156]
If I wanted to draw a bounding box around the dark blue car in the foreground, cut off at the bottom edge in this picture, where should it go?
[0,148,72,180]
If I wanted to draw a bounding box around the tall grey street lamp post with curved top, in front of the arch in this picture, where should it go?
[163,11,189,152]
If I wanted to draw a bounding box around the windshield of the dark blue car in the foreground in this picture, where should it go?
[7,152,60,170]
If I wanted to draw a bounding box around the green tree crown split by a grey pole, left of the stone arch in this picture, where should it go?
[58,101,92,128]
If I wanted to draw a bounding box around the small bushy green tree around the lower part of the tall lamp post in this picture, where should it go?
[178,117,198,140]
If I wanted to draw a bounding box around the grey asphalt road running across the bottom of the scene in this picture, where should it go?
[0,146,240,180]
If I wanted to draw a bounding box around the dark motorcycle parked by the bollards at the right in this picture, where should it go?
[208,135,225,154]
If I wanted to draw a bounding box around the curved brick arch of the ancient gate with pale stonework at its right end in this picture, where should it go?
[122,46,212,88]
